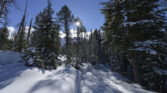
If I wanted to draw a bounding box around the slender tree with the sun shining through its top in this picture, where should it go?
[73,17,87,68]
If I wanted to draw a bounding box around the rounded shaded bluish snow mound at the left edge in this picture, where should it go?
[0,51,22,65]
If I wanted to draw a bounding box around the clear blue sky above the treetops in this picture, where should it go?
[9,0,108,31]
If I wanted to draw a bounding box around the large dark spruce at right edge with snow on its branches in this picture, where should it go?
[124,0,167,92]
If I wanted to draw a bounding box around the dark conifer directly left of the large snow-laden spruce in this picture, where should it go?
[102,0,128,73]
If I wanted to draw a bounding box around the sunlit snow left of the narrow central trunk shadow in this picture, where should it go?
[0,63,76,93]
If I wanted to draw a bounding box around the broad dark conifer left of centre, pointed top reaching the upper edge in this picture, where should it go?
[27,0,60,69]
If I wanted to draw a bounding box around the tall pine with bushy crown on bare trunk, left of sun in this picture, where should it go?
[57,5,74,61]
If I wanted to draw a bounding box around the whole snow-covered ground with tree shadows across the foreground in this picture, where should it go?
[0,51,155,93]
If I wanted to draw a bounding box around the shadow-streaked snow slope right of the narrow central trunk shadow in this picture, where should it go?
[81,66,154,93]
